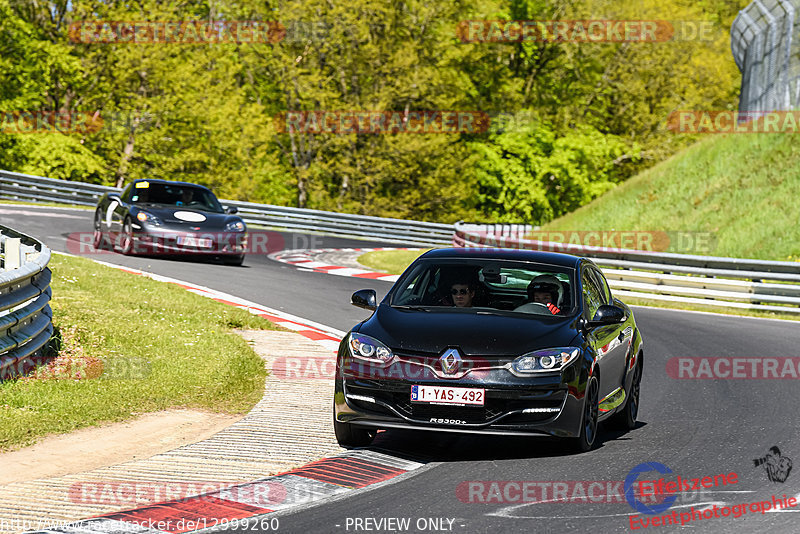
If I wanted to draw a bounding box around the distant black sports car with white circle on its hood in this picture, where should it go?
[93,180,247,265]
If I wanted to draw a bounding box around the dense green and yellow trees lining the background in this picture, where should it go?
[0,0,747,223]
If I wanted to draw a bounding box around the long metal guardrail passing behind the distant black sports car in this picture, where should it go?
[0,171,453,245]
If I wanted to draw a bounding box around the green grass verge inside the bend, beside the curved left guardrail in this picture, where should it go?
[0,255,277,450]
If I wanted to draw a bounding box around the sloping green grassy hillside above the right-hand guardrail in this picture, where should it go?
[542,134,800,261]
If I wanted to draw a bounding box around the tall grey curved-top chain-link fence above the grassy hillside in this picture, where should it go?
[731,0,800,113]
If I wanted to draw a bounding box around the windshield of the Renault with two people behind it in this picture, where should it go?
[391,259,575,316]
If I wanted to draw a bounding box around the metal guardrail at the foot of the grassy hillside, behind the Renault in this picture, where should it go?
[453,223,800,313]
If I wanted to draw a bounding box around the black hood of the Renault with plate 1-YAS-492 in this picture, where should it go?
[359,304,578,356]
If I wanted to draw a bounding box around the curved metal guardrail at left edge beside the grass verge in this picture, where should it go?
[0,226,53,380]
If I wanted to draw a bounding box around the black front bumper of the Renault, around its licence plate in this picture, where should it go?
[334,355,587,437]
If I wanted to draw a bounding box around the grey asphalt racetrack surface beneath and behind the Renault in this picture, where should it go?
[6,205,800,533]
